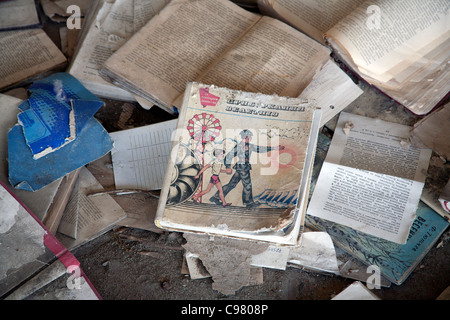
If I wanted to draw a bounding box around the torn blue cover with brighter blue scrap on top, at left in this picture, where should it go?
[8,73,113,191]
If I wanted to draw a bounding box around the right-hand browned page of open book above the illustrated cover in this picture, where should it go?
[190,17,330,103]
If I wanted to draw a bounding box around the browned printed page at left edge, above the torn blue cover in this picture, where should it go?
[0,29,66,88]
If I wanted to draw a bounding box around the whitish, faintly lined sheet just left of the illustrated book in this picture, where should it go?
[110,119,177,190]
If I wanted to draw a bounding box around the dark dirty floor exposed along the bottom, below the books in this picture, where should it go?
[67,225,450,300]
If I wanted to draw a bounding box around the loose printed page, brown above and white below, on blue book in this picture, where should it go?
[308,112,431,243]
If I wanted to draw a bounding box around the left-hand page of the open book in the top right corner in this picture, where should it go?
[258,0,364,43]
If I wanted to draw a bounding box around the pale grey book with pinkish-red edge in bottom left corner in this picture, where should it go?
[0,180,101,300]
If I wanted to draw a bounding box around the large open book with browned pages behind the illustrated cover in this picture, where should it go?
[101,0,362,118]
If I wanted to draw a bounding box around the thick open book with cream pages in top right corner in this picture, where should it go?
[258,0,450,115]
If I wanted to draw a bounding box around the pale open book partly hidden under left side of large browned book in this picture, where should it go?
[68,0,168,101]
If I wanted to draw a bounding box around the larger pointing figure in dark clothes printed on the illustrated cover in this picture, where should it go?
[209,129,284,209]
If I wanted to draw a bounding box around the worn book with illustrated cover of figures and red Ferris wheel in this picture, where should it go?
[155,82,321,245]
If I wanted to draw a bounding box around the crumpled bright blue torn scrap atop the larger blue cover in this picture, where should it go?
[18,72,103,159]
